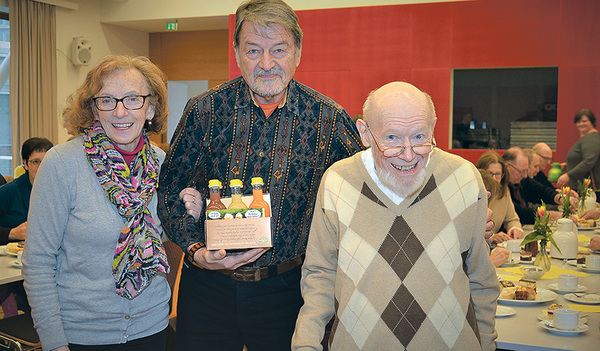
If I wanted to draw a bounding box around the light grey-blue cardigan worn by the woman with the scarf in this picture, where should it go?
[23,137,171,350]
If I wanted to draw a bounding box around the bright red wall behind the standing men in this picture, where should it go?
[229,0,600,166]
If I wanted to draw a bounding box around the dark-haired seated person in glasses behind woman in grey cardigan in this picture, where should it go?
[0,138,52,245]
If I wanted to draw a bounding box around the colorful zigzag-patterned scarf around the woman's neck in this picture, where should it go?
[83,121,169,299]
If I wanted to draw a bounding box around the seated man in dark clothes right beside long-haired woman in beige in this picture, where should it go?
[502,146,578,224]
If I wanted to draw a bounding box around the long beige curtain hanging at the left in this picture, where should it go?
[9,0,58,168]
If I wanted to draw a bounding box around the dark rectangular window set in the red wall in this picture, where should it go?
[451,67,558,149]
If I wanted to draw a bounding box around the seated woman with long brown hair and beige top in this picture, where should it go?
[475,151,524,244]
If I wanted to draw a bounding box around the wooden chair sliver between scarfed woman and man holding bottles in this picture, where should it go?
[163,241,183,350]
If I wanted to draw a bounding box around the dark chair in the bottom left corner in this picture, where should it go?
[0,313,42,351]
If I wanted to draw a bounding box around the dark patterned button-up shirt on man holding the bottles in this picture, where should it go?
[158,77,363,266]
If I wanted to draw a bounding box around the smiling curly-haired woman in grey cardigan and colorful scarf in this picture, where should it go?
[23,55,199,351]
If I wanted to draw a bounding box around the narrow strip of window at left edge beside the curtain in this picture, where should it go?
[0,7,8,176]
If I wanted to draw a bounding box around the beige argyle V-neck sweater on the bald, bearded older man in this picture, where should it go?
[292,149,499,351]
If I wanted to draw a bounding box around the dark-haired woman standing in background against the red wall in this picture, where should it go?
[556,108,600,198]
